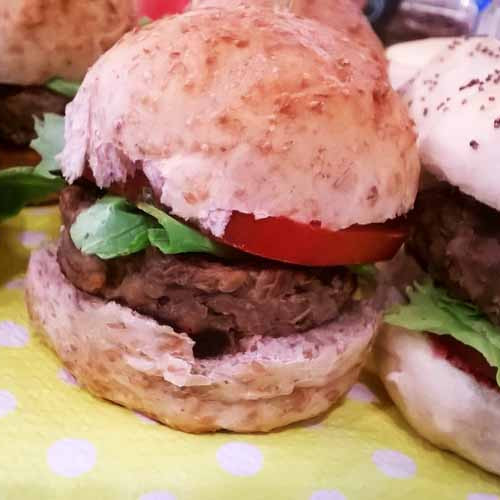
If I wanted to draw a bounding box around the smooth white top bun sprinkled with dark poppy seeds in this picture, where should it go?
[402,37,500,210]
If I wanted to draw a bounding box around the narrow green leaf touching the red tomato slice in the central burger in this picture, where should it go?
[137,203,236,257]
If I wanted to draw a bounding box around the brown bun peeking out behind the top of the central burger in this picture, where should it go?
[191,0,384,60]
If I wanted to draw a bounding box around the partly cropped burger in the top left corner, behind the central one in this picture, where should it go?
[0,0,136,154]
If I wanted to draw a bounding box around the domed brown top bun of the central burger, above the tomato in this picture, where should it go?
[61,6,419,236]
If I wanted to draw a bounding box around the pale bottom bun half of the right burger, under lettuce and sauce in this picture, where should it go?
[374,325,500,474]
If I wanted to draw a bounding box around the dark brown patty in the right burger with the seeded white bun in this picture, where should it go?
[406,183,500,326]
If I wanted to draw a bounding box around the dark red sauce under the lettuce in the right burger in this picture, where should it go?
[428,333,500,392]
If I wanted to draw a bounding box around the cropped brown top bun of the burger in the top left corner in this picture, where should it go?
[0,0,136,85]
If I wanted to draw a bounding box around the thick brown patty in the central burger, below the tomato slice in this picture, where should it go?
[58,186,356,351]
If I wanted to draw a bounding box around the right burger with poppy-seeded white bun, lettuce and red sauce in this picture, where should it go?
[376,38,500,474]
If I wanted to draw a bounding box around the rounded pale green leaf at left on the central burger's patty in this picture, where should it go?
[70,196,155,259]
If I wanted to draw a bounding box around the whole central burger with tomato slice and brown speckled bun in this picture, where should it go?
[27,2,419,432]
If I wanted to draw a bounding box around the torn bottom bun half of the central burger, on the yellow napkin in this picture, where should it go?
[26,249,379,432]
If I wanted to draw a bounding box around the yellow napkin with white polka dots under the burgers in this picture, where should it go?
[0,208,500,500]
